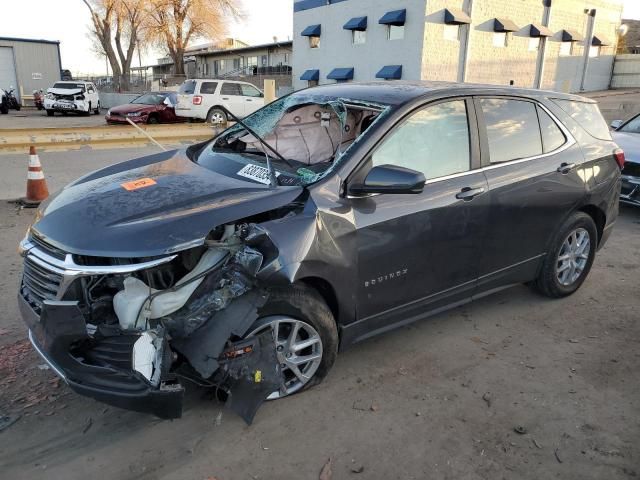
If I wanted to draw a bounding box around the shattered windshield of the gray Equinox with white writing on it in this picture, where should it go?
[193,94,388,185]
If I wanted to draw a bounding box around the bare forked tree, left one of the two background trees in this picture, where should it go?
[82,0,149,90]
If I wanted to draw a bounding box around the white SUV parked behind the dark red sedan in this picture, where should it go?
[176,79,264,123]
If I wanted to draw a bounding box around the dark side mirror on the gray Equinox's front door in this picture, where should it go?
[349,165,427,196]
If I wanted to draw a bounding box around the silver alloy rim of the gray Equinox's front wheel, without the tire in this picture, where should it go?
[247,316,322,400]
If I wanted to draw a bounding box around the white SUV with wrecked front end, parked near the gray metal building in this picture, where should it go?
[44,80,100,117]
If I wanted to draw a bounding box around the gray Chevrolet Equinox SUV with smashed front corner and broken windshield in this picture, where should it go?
[18,82,624,422]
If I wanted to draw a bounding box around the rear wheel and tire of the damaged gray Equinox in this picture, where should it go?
[534,212,598,298]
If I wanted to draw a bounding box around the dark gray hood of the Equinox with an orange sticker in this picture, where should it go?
[32,150,303,257]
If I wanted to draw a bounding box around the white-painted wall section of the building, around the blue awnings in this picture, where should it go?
[293,0,425,89]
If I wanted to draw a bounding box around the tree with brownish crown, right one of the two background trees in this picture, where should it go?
[147,0,242,75]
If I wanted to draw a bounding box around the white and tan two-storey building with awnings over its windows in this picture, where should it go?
[293,0,622,92]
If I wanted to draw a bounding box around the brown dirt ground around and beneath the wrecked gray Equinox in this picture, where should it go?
[0,196,640,480]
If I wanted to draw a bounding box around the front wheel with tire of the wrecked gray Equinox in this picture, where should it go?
[246,285,338,399]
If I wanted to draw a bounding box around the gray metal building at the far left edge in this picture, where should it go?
[0,37,62,103]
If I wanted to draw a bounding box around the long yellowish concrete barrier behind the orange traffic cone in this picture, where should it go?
[0,123,219,153]
